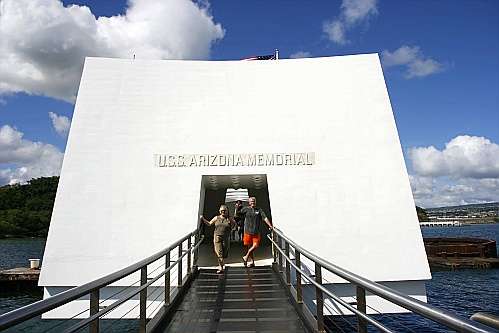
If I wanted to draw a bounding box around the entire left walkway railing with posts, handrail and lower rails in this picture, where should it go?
[0,230,204,333]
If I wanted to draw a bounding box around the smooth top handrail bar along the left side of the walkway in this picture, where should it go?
[0,229,204,330]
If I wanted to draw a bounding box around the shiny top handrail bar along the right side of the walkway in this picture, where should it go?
[267,228,497,333]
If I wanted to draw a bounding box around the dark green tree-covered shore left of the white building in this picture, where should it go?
[0,176,59,238]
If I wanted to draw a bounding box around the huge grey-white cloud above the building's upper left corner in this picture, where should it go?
[0,0,225,102]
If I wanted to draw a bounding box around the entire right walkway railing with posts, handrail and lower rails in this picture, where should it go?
[267,228,497,333]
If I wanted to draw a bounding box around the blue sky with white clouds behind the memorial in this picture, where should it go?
[0,0,499,208]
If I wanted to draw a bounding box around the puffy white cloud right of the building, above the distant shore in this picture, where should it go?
[407,135,499,208]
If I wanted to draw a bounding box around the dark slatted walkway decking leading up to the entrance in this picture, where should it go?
[159,266,307,332]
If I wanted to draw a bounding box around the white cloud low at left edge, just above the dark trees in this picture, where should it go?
[0,125,64,186]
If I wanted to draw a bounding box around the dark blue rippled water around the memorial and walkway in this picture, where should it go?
[0,223,499,333]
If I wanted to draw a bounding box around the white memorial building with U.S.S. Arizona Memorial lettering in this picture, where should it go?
[39,54,431,317]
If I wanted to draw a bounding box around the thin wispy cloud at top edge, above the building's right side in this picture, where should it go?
[322,0,378,45]
